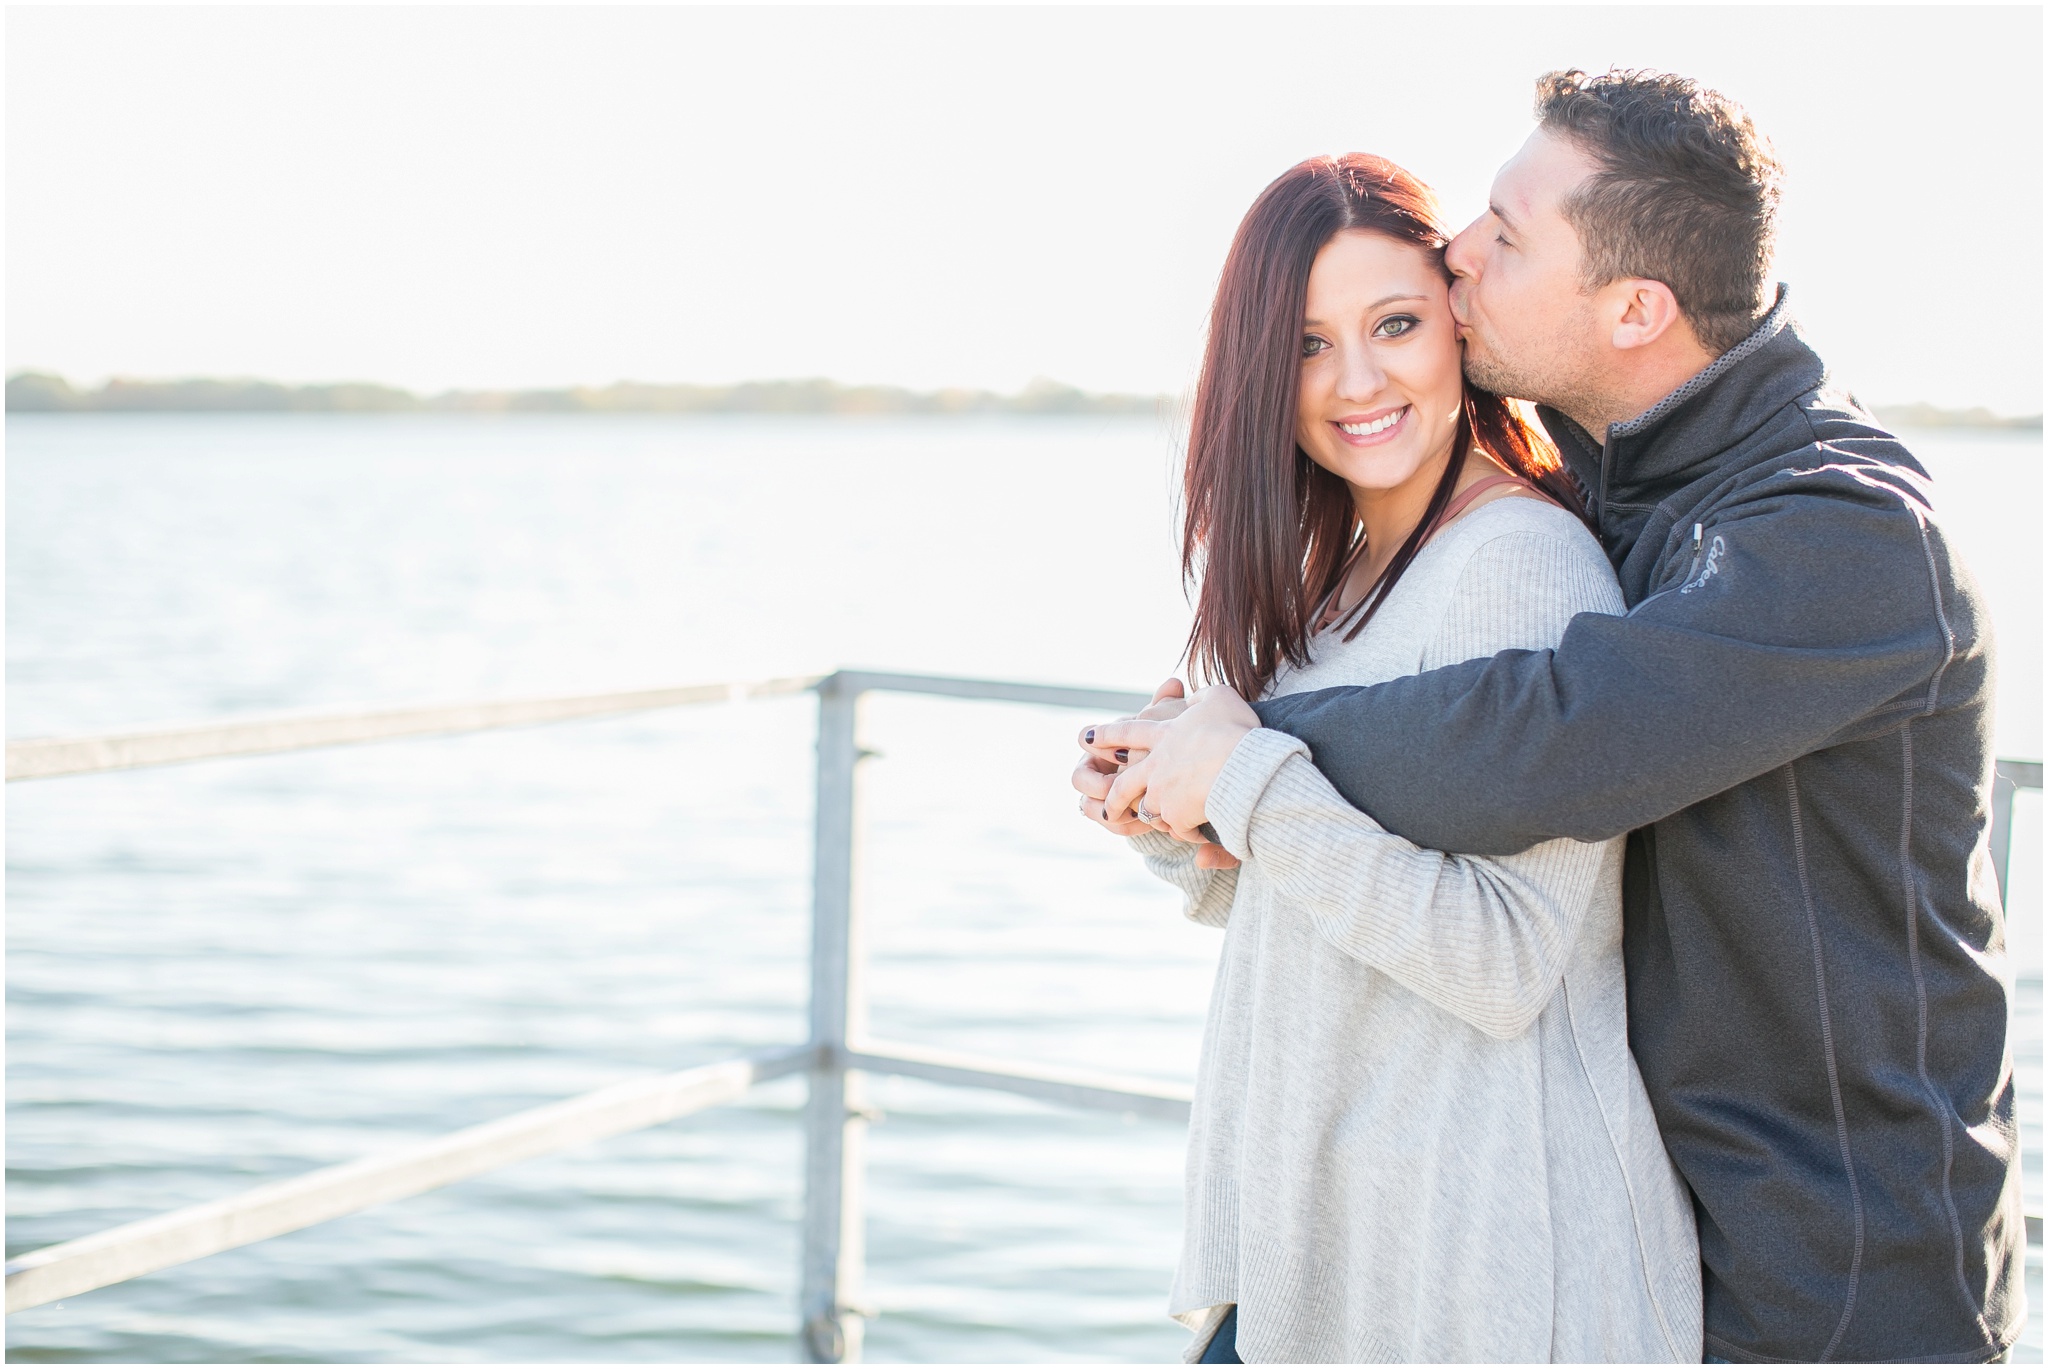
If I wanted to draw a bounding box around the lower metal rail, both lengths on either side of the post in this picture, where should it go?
[6,1041,1192,1314]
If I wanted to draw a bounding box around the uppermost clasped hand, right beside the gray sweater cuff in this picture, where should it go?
[1094,685,1260,842]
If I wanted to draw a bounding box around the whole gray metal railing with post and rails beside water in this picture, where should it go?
[6,670,2042,1363]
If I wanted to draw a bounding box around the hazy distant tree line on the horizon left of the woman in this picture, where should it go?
[6,371,1169,414]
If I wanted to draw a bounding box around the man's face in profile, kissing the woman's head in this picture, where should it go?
[1444,129,1604,414]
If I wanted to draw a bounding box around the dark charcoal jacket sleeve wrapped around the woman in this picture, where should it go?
[1253,469,1960,853]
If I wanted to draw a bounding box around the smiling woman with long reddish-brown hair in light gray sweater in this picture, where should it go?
[1077,156,1700,1363]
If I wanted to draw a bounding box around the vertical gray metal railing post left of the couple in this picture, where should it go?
[799,672,866,1365]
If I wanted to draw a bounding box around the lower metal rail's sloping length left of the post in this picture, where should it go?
[6,1045,817,1314]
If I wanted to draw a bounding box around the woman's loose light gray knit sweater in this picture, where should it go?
[1133,498,1700,1363]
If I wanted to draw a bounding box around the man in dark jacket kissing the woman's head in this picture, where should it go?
[1075,72,2025,1361]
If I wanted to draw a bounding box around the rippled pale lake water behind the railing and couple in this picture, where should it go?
[6,416,2042,1361]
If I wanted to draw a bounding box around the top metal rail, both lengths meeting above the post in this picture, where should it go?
[6,670,1147,781]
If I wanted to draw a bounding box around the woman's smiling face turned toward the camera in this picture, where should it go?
[1294,232,1464,494]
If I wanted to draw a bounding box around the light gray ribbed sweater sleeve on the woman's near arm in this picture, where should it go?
[1208,531,1622,1037]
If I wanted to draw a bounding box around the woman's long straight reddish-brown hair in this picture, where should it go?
[1180,152,1583,699]
